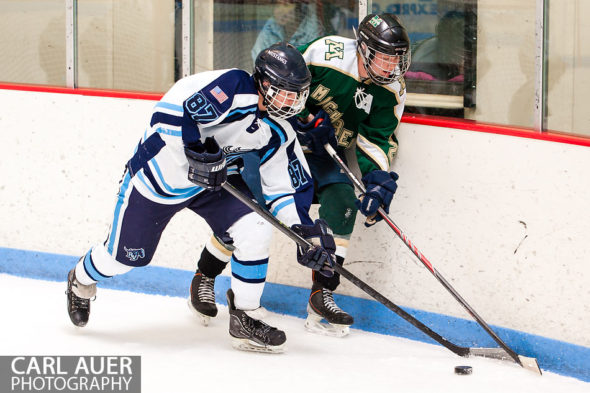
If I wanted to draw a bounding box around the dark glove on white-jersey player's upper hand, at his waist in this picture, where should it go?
[184,137,227,191]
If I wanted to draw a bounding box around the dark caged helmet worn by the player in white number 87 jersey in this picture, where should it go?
[253,42,311,119]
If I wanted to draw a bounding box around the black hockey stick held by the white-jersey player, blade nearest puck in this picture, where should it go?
[223,182,524,360]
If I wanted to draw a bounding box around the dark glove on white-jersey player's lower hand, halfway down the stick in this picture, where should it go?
[291,220,336,277]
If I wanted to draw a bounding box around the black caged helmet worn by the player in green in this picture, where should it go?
[356,14,411,85]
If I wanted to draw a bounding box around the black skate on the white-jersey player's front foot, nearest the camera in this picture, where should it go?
[227,289,287,353]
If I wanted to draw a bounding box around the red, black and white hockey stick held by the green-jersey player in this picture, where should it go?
[324,143,541,374]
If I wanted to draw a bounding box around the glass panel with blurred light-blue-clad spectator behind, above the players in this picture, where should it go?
[202,0,358,70]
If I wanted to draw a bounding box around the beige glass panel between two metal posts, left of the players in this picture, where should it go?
[78,0,175,92]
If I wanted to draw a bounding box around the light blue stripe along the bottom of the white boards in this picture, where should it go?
[0,247,590,382]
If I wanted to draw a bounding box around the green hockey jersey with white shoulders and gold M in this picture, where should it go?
[299,36,406,175]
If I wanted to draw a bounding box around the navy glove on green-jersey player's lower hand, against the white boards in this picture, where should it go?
[355,170,399,227]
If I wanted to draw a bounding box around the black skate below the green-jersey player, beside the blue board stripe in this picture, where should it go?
[305,282,354,337]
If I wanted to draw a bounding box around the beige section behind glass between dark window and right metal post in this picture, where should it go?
[465,0,536,128]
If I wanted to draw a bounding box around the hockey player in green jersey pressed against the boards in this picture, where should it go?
[298,14,410,336]
